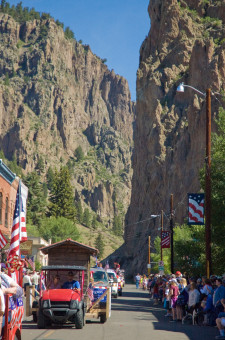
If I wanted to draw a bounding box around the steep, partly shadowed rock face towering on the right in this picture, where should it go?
[124,0,225,271]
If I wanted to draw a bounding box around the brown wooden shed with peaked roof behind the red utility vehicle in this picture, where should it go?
[40,238,98,290]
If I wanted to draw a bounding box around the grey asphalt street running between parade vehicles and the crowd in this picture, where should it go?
[22,285,219,340]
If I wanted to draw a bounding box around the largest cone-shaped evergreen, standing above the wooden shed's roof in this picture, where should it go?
[48,167,76,221]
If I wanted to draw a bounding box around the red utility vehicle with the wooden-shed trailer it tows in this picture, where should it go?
[27,239,111,328]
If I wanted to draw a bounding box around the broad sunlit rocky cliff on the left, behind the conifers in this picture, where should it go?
[0,13,135,224]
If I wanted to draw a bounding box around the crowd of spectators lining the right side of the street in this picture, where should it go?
[135,271,225,339]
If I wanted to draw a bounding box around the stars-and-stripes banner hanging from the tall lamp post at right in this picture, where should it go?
[188,194,205,225]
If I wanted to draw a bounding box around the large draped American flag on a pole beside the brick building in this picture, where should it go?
[8,183,27,256]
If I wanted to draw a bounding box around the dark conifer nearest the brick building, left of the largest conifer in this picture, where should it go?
[24,172,46,226]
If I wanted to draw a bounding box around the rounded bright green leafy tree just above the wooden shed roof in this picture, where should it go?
[39,217,80,243]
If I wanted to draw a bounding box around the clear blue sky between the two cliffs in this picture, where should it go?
[7,0,150,100]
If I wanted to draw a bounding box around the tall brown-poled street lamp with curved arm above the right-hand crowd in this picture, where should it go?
[177,83,212,278]
